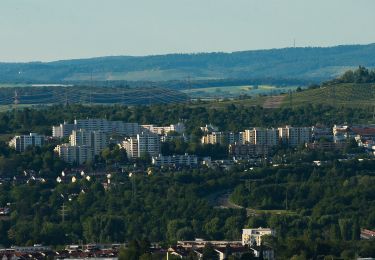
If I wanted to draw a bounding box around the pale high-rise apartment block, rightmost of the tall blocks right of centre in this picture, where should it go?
[279,125,312,147]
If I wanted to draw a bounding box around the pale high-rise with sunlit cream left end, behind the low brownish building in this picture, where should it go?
[243,127,279,146]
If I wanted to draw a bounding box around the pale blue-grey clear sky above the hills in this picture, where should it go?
[0,0,375,62]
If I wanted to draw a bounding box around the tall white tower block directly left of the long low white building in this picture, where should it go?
[122,133,160,159]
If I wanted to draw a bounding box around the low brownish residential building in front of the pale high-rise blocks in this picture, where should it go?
[228,143,271,158]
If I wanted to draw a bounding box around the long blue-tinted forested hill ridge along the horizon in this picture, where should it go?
[0,44,375,83]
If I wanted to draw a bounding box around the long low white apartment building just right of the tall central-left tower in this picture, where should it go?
[152,154,198,167]
